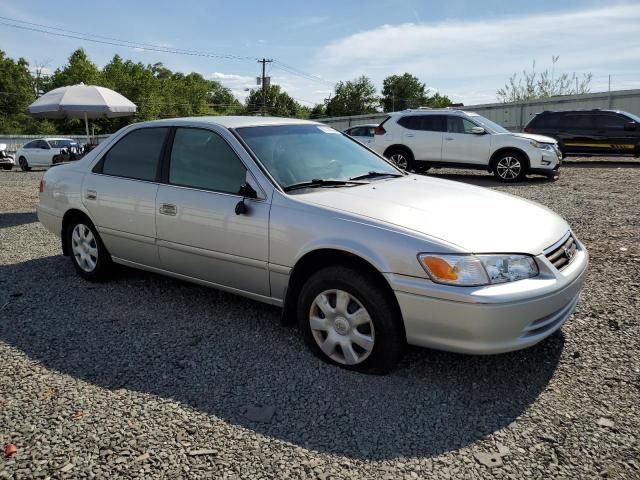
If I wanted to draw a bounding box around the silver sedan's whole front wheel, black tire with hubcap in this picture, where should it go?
[297,265,406,374]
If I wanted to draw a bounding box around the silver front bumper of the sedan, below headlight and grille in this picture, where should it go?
[387,239,588,354]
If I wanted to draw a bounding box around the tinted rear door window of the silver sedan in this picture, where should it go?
[101,127,169,181]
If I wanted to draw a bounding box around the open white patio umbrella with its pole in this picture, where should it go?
[28,83,137,142]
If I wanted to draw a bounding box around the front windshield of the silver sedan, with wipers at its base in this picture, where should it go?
[236,125,402,189]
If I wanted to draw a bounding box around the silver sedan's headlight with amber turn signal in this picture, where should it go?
[418,253,538,287]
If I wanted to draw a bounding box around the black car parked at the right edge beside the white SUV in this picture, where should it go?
[524,110,640,157]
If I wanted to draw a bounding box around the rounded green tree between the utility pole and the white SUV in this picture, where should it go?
[326,75,379,117]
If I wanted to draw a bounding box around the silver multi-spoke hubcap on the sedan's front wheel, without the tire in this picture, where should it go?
[309,290,375,365]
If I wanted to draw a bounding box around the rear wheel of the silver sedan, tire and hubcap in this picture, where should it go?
[65,217,112,282]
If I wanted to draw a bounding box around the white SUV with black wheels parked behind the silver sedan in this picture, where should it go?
[369,109,562,182]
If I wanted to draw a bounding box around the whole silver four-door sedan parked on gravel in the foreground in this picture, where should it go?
[38,117,588,373]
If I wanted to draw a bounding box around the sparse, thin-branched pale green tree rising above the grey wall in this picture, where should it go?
[496,56,593,102]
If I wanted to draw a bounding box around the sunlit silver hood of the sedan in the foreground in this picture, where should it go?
[295,175,569,255]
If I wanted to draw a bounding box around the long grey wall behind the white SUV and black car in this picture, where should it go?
[318,90,640,132]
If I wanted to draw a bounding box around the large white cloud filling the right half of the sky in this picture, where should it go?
[318,4,640,104]
